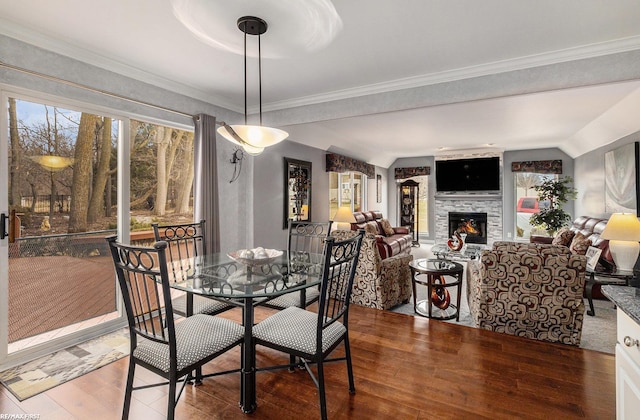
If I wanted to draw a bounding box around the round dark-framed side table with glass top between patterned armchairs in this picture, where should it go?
[409,258,464,321]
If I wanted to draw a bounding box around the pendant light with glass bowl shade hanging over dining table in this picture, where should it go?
[217,16,289,156]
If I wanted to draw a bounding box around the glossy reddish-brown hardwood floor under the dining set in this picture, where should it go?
[0,305,615,420]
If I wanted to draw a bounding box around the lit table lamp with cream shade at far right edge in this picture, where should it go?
[600,213,640,272]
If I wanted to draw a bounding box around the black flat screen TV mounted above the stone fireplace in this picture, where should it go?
[436,156,500,192]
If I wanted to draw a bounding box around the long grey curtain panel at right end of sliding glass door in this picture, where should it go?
[193,114,220,252]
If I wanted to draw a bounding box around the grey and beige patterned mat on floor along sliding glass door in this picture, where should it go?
[0,328,129,401]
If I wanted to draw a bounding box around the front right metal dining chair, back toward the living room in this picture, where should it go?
[253,231,364,419]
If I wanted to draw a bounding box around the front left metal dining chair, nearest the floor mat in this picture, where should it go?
[107,236,244,419]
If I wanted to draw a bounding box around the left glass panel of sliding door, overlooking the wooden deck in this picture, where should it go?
[2,96,120,355]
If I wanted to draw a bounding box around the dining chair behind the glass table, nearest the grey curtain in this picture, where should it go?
[151,220,236,316]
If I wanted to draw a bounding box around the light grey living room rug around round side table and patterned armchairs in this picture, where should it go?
[391,244,616,354]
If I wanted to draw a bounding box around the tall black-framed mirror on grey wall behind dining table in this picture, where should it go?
[283,157,311,229]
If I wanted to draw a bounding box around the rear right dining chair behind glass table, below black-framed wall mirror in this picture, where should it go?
[264,221,333,309]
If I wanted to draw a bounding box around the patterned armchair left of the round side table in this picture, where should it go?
[331,230,413,310]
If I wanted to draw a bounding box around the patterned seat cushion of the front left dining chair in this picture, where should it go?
[133,314,244,372]
